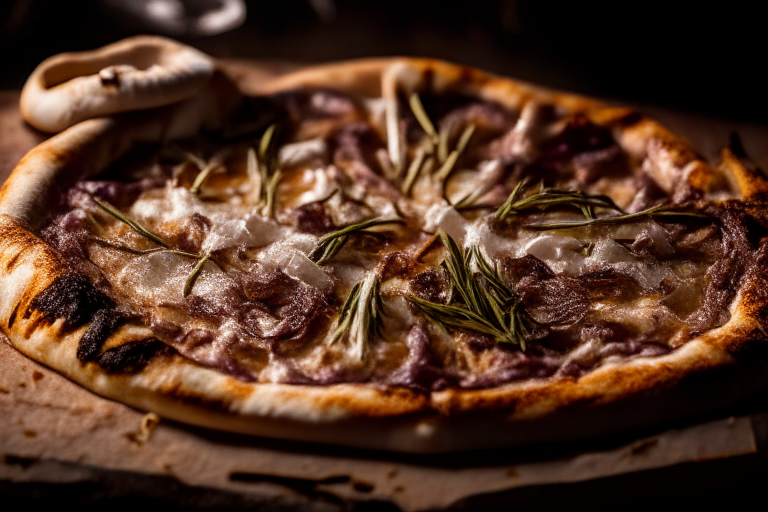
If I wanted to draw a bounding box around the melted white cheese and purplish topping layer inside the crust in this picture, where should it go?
[37,90,732,390]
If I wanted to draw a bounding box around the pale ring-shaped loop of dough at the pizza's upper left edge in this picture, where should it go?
[20,36,215,133]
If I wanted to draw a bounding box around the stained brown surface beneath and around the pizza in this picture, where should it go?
[0,62,768,510]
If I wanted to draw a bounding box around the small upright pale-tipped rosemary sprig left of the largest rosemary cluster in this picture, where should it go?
[331,272,384,359]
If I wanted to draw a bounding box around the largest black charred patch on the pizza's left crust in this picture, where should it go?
[24,273,115,330]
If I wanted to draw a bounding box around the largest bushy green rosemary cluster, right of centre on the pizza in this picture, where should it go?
[408,232,535,350]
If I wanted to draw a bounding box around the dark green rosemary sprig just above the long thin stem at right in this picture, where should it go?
[496,181,621,222]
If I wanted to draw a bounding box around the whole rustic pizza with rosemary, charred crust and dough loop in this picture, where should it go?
[0,37,768,452]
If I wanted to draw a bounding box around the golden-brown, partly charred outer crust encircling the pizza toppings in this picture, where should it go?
[0,44,768,453]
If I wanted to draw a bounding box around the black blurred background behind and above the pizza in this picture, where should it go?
[0,0,768,123]
